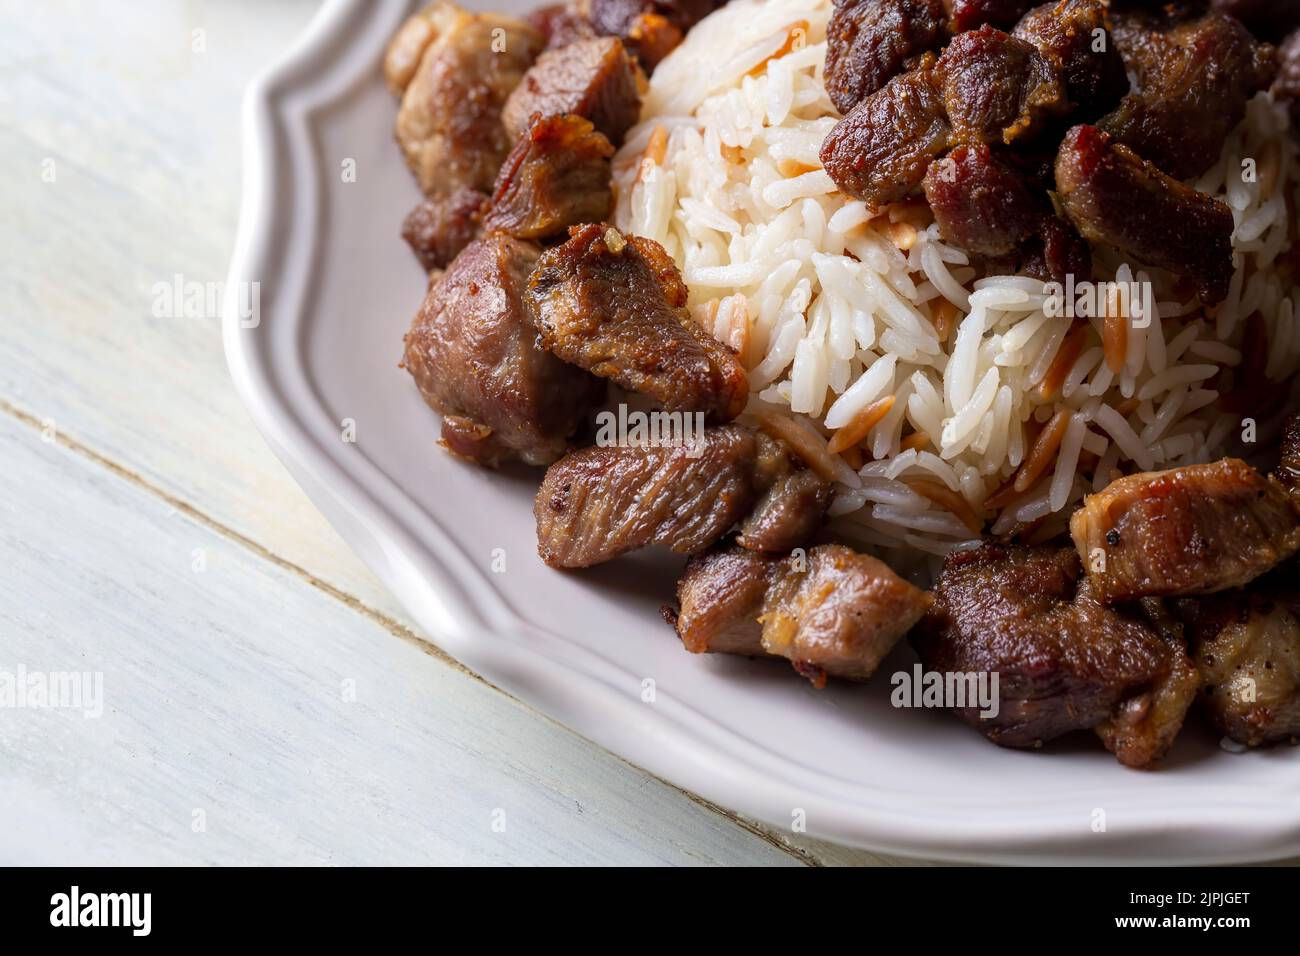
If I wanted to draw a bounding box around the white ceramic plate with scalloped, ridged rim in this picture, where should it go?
[224,0,1300,862]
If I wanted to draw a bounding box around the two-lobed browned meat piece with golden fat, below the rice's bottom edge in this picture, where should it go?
[677,545,931,687]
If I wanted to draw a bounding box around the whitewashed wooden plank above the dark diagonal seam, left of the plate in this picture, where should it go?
[0,0,909,862]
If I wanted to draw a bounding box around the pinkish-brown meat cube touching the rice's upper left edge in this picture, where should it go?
[502,36,645,146]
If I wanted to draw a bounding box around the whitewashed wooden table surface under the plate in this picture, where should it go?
[0,0,946,865]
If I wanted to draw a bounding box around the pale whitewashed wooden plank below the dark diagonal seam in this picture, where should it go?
[0,416,800,865]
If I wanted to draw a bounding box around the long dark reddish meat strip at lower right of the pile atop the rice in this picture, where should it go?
[1056,126,1234,304]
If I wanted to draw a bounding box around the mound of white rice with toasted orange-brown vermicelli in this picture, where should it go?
[615,0,1300,555]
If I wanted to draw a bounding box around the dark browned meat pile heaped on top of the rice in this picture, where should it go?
[822,0,1284,304]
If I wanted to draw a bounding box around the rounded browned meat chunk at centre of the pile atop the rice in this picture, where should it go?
[935,26,1070,143]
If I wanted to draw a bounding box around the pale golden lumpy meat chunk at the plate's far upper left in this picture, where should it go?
[385,0,542,198]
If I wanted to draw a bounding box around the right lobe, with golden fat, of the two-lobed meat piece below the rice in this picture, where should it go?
[763,545,933,687]
